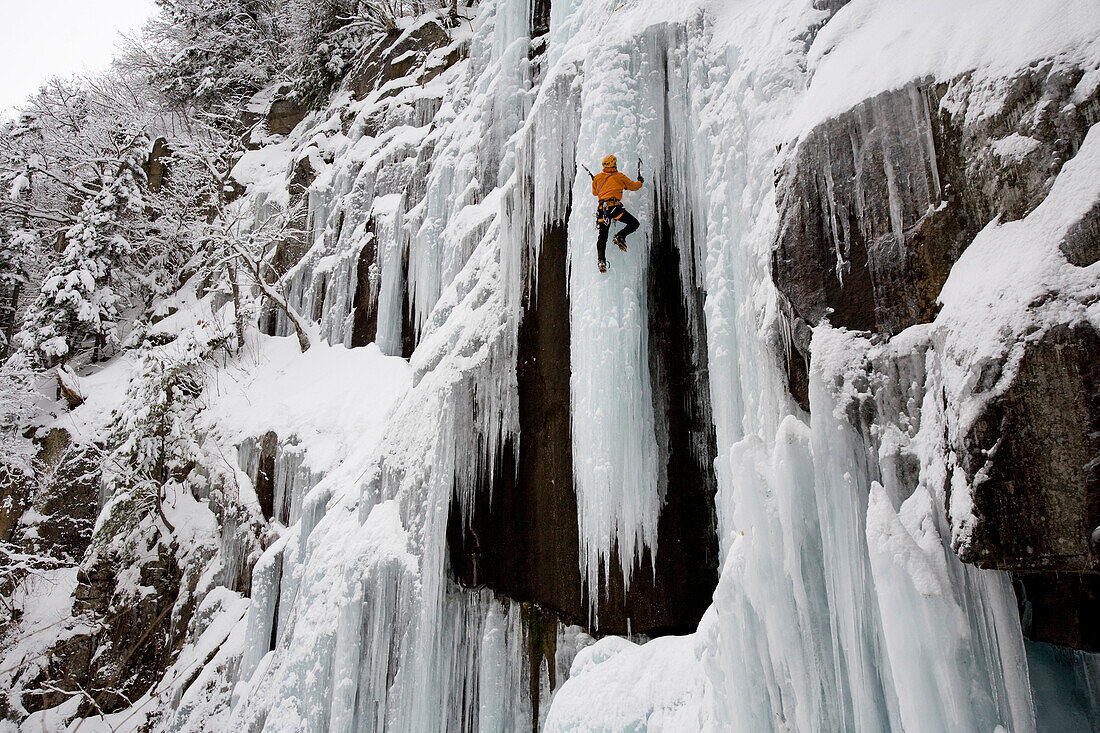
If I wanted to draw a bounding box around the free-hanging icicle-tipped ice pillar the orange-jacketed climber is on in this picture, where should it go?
[569,25,664,604]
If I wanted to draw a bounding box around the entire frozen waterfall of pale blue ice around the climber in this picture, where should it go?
[155,0,1098,733]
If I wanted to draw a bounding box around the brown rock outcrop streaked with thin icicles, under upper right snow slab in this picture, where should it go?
[772,62,1100,335]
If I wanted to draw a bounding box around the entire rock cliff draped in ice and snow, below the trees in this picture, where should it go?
[0,0,1100,733]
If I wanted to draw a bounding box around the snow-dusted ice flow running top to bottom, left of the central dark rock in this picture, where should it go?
[227,0,598,733]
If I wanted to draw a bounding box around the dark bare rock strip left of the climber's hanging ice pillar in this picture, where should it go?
[448,217,585,623]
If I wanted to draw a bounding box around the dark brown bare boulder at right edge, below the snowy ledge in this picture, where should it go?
[959,324,1100,572]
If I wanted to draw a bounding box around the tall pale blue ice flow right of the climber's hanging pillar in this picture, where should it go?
[556,2,1056,731]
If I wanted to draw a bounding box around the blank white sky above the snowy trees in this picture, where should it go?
[0,0,153,118]
